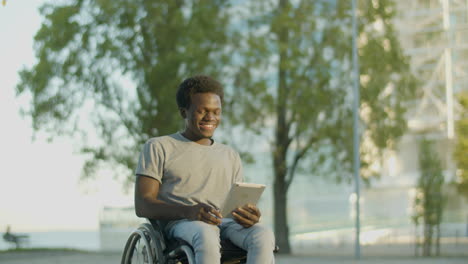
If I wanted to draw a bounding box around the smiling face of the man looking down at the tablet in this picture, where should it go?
[181,93,221,144]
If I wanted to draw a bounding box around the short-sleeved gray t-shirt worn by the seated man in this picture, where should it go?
[135,133,243,208]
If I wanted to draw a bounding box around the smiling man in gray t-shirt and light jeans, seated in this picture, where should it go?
[135,76,275,264]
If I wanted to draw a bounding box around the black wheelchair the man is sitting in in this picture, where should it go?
[121,219,250,264]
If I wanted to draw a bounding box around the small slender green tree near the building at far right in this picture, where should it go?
[413,139,444,256]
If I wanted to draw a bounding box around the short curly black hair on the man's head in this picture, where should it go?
[176,75,224,109]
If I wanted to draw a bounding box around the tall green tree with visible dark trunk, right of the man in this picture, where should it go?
[231,0,416,253]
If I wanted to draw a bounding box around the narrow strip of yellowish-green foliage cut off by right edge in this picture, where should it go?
[454,92,468,197]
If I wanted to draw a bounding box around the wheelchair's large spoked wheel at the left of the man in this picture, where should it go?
[121,224,165,264]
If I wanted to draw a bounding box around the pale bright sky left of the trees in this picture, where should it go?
[0,0,133,232]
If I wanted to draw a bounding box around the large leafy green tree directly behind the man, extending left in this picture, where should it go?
[17,0,230,186]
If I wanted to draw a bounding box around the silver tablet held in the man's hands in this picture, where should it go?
[220,182,266,218]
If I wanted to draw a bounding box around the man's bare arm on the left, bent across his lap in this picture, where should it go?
[135,175,221,225]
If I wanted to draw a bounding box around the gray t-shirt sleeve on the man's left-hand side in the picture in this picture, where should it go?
[135,141,164,183]
